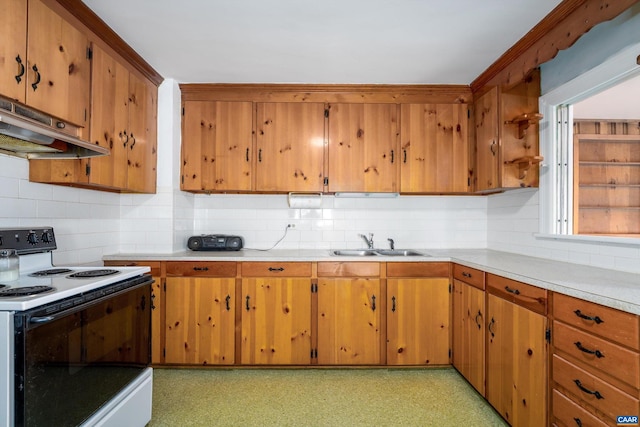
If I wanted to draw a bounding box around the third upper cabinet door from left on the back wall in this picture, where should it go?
[328,104,399,192]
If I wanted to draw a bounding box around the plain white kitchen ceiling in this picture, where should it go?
[83,0,560,84]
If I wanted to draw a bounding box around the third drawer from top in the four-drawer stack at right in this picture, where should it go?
[553,354,638,420]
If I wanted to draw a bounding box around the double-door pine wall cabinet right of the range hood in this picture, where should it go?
[89,45,157,193]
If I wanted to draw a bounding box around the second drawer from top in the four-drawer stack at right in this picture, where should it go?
[553,320,640,388]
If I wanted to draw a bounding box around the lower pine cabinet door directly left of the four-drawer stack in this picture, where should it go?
[486,295,548,427]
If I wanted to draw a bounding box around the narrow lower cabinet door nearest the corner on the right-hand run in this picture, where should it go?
[453,280,485,396]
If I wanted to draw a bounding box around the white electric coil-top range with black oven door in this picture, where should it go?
[0,227,153,427]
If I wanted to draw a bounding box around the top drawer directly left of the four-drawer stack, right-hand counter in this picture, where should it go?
[487,273,547,314]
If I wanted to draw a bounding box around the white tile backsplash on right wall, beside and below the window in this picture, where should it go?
[487,189,640,273]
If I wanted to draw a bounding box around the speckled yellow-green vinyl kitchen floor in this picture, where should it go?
[149,368,507,427]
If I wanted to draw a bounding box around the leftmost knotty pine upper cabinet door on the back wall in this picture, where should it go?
[181,101,253,191]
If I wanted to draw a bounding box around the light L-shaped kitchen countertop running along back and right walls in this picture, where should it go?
[103,249,640,315]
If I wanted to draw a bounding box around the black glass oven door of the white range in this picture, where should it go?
[14,276,153,426]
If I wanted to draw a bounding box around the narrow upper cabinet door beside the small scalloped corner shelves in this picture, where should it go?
[474,87,502,191]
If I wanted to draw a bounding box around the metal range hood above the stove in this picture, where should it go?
[0,99,109,159]
